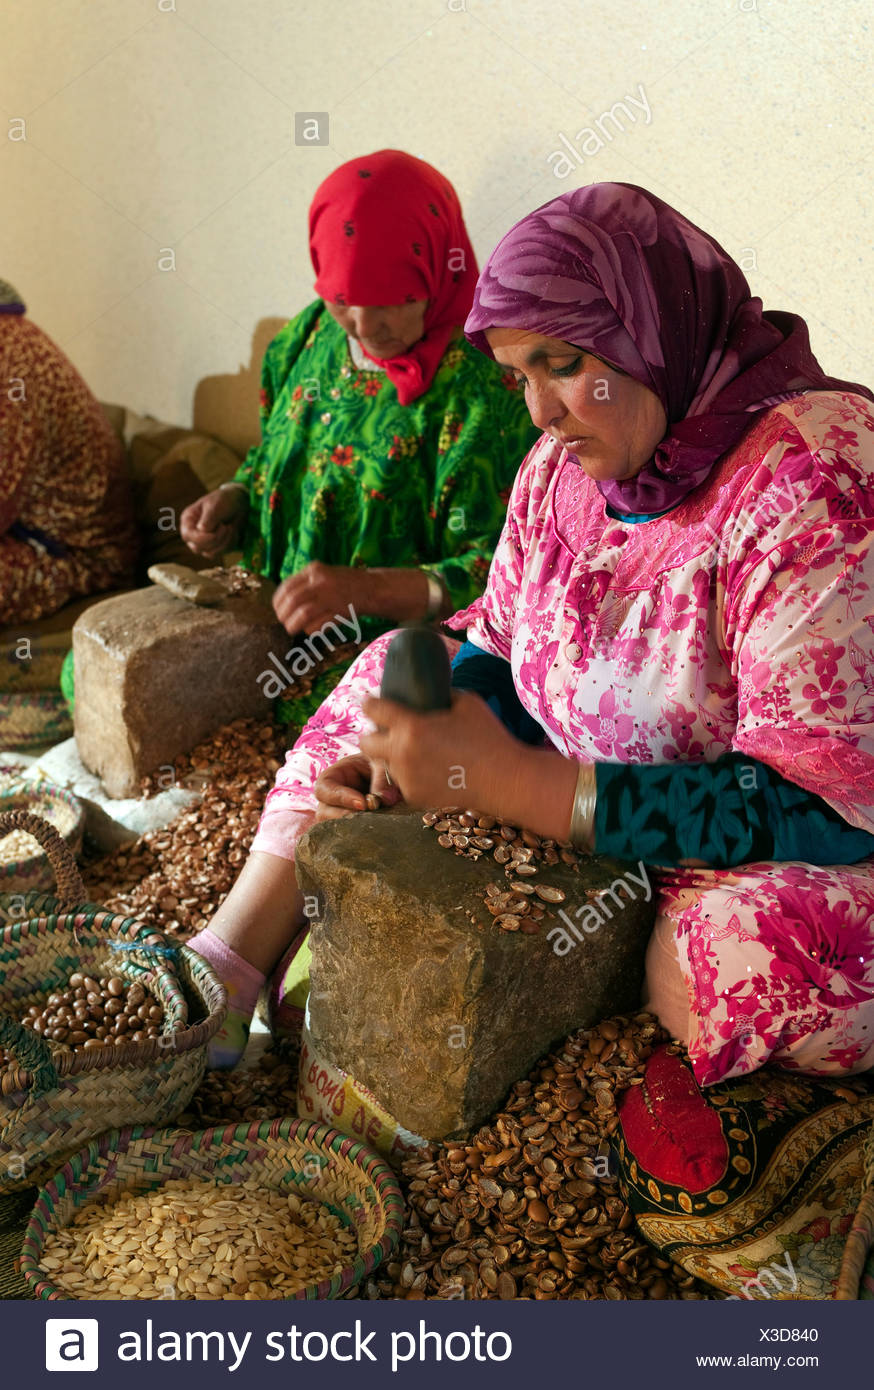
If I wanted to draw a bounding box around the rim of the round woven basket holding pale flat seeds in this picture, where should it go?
[17,1118,406,1302]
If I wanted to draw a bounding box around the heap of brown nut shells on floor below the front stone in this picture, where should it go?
[361,1013,713,1300]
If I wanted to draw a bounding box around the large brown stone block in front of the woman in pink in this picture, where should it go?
[296,812,656,1140]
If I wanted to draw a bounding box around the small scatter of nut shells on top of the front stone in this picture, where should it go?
[422,806,579,935]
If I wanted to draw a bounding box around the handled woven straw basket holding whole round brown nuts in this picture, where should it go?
[0,812,226,1191]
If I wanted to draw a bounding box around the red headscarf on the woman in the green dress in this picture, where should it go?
[310,150,478,406]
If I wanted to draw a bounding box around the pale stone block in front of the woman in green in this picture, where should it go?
[72,566,289,796]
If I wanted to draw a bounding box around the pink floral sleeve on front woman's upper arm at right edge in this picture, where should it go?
[725,433,874,831]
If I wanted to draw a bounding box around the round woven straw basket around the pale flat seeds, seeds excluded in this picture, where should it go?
[19,1119,403,1301]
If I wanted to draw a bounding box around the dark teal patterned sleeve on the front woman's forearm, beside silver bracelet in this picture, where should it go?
[595,753,874,869]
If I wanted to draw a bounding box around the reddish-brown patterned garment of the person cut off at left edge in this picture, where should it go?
[0,314,136,624]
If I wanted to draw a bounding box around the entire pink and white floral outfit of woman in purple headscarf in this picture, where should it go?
[253,392,874,1084]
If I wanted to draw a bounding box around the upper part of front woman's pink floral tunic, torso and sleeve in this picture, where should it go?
[449,392,874,830]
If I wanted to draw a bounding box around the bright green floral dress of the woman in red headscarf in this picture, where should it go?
[235,299,539,724]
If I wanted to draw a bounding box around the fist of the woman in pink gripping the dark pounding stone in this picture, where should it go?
[360,691,524,815]
